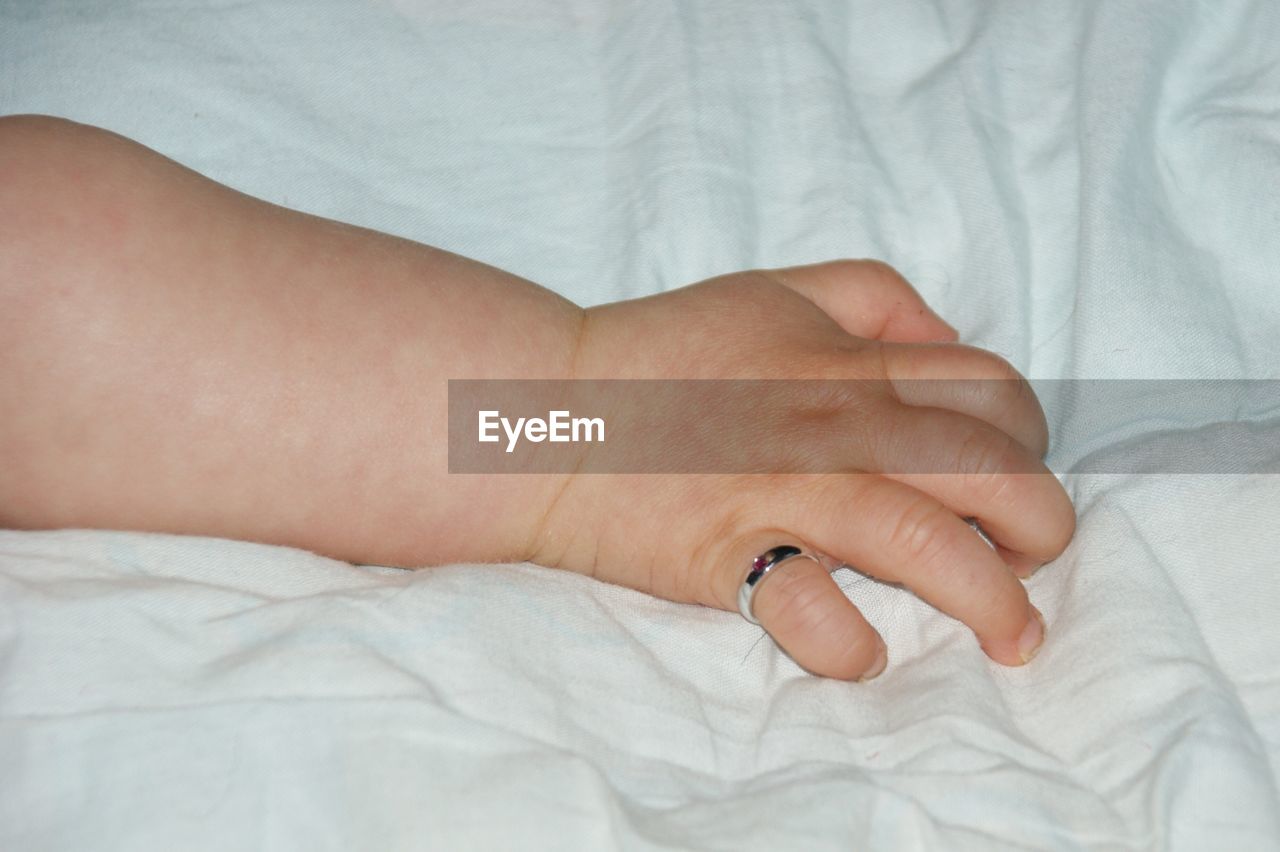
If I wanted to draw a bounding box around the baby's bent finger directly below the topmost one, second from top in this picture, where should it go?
[882,344,1048,458]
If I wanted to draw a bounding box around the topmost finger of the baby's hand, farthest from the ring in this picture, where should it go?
[760,260,959,343]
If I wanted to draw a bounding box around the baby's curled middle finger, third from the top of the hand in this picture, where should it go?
[867,406,1075,576]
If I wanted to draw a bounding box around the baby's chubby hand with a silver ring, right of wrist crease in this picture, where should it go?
[532,261,1075,678]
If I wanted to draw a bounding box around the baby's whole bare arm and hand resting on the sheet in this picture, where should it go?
[0,116,1075,679]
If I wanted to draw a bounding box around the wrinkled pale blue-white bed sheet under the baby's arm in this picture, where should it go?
[0,0,1280,849]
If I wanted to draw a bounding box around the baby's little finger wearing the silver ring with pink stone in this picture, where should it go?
[714,524,888,681]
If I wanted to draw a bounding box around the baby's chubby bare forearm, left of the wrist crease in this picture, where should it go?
[0,112,581,564]
